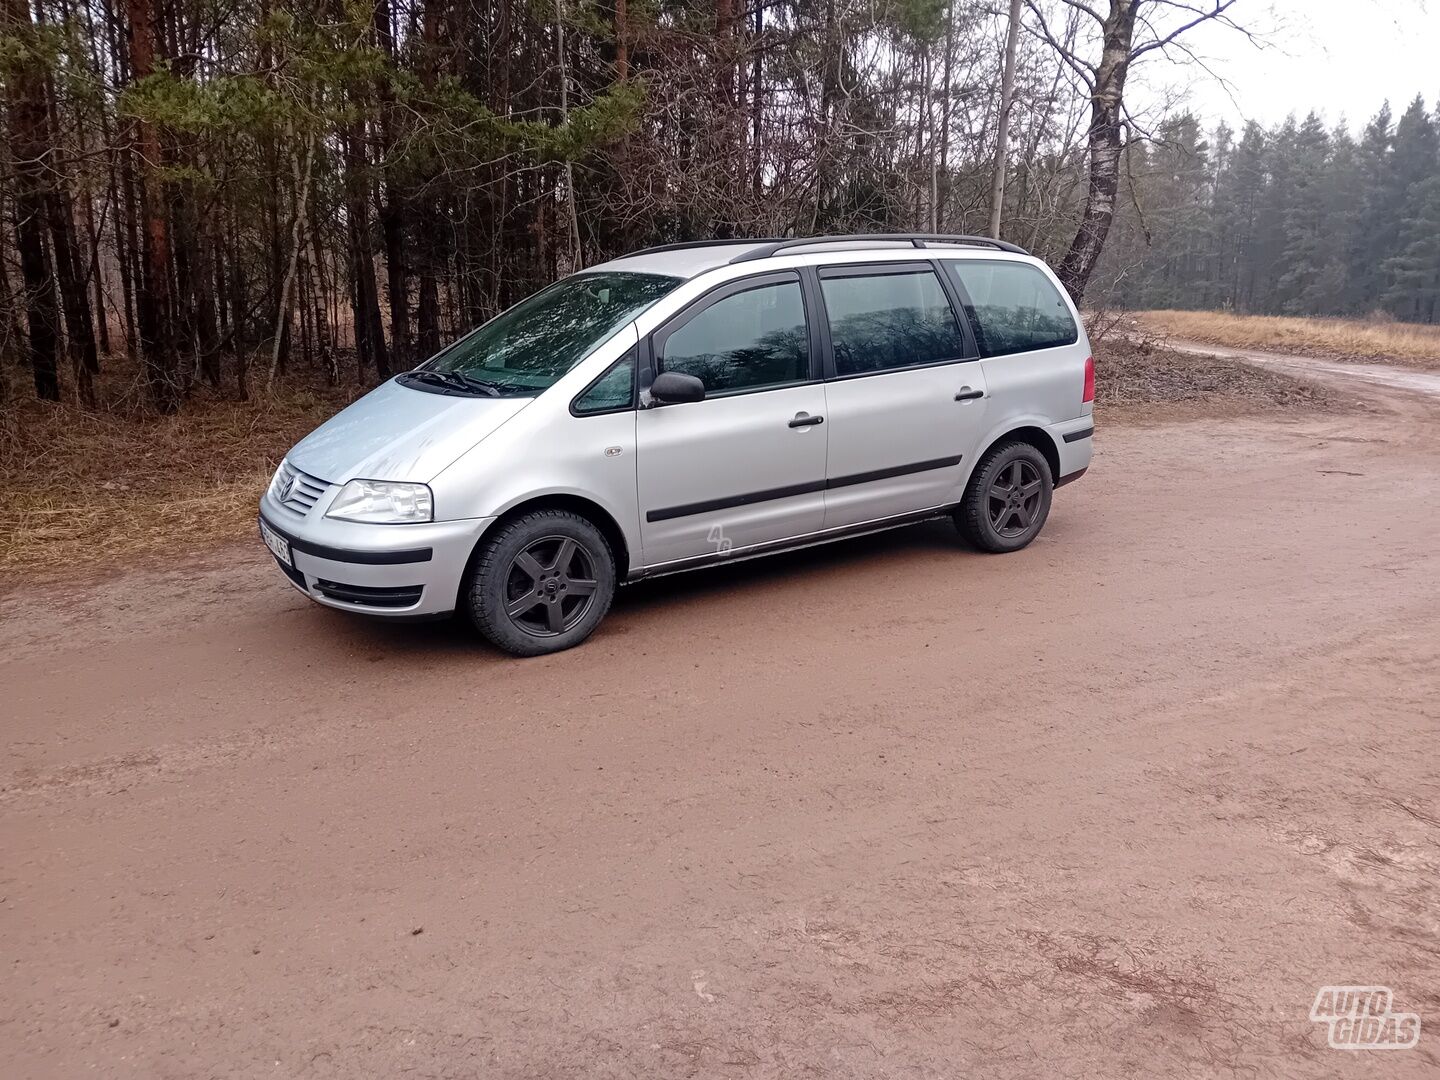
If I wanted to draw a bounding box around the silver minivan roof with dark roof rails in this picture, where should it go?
[586,233,1030,281]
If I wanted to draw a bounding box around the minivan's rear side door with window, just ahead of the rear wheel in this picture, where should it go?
[816,261,986,528]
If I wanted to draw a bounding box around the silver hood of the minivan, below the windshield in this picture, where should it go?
[285,379,534,484]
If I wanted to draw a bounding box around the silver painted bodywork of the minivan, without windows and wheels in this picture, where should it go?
[261,246,1093,616]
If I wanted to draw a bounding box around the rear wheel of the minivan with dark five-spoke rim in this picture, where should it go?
[955,441,1056,553]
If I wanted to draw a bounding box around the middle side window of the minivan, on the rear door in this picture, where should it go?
[819,266,965,376]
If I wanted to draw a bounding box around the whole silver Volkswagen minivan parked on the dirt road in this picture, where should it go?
[259,235,1094,655]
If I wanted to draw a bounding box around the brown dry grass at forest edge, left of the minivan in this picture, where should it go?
[0,377,359,582]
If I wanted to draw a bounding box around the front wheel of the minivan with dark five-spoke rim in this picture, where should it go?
[468,510,615,657]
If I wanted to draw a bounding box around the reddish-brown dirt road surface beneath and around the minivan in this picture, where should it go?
[0,383,1440,1077]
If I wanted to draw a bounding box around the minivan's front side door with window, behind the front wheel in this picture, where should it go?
[635,271,828,567]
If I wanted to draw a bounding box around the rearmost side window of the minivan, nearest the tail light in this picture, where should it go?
[949,259,1080,356]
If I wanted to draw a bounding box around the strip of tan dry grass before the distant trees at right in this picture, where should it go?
[1135,311,1440,367]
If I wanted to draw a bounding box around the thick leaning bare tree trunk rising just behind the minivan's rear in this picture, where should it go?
[1057,0,1138,304]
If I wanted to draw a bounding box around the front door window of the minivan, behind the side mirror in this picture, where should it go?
[658,281,809,395]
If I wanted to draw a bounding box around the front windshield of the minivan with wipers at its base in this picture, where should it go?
[418,272,680,397]
